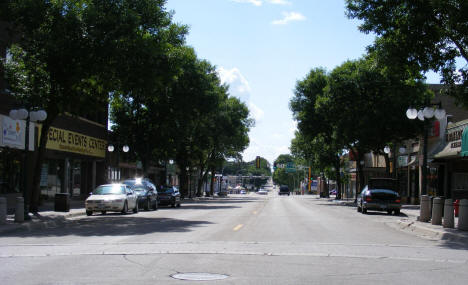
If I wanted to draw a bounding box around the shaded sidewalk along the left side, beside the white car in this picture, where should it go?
[0,196,86,236]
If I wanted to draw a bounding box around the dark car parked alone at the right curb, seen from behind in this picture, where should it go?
[357,186,401,215]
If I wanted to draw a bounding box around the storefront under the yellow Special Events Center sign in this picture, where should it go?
[40,116,107,199]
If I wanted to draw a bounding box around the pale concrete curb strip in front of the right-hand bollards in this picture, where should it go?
[386,219,468,244]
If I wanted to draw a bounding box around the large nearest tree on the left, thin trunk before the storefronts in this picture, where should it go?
[0,0,184,212]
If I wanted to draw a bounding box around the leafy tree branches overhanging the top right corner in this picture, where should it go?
[346,0,468,107]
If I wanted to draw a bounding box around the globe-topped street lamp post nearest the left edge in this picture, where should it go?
[9,108,47,217]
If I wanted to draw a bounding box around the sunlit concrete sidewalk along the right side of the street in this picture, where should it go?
[328,198,468,244]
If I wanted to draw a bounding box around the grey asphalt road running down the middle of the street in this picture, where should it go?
[0,189,468,284]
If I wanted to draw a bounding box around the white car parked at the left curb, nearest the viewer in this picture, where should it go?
[85,184,138,216]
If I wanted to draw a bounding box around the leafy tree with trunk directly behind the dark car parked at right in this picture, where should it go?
[320,55,431,192]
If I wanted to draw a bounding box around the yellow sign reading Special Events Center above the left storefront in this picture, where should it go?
[46,127,107,158]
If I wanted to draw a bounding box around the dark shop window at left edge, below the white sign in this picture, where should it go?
[0,148,21,194]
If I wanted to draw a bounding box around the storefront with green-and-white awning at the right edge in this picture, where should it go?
[434,120,468,199]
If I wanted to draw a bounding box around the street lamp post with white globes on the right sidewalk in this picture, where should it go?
[406,104,446,195]
